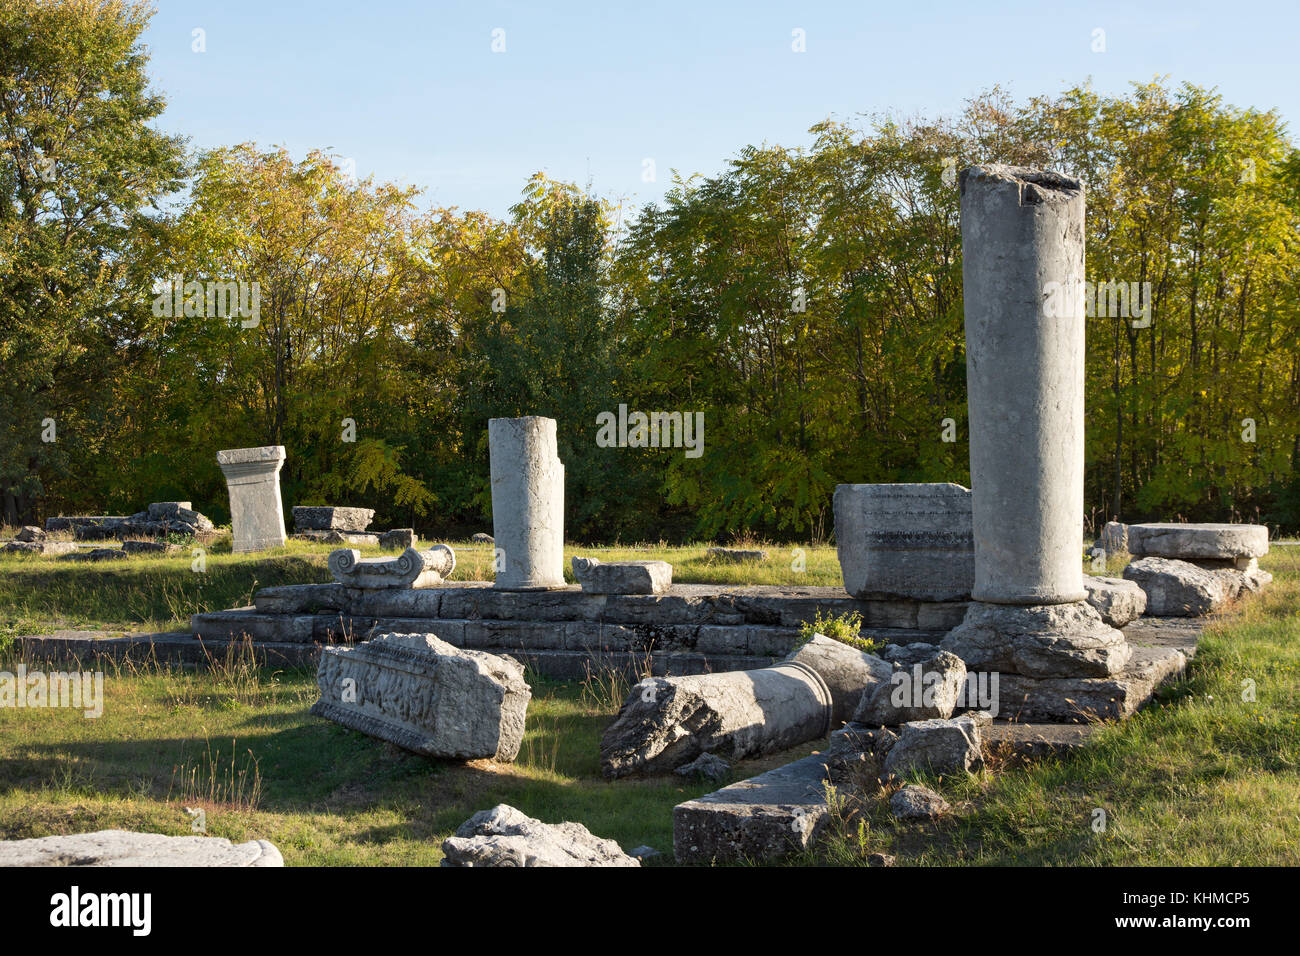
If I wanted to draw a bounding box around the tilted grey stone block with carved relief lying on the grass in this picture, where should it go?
[312,633,532,761]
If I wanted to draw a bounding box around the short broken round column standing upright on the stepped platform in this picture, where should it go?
[488,415,564,591]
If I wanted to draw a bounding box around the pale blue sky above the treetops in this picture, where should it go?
[144,0,1300,215]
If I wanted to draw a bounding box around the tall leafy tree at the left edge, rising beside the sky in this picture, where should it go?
[0,0,183,523]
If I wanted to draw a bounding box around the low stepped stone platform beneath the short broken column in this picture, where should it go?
[191,581,966,679]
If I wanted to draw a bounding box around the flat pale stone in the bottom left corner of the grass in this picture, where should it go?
[0,830,285,866]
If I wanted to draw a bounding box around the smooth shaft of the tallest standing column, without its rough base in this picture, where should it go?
[961,165,1086,605]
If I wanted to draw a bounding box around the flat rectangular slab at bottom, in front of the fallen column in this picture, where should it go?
[672,753,829,864]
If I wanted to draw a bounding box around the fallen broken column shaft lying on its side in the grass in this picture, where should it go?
[601,661,832,778]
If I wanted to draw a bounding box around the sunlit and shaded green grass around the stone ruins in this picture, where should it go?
[0,545,1300,865]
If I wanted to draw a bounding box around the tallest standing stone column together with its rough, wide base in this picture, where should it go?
[943,165,1132,686]
